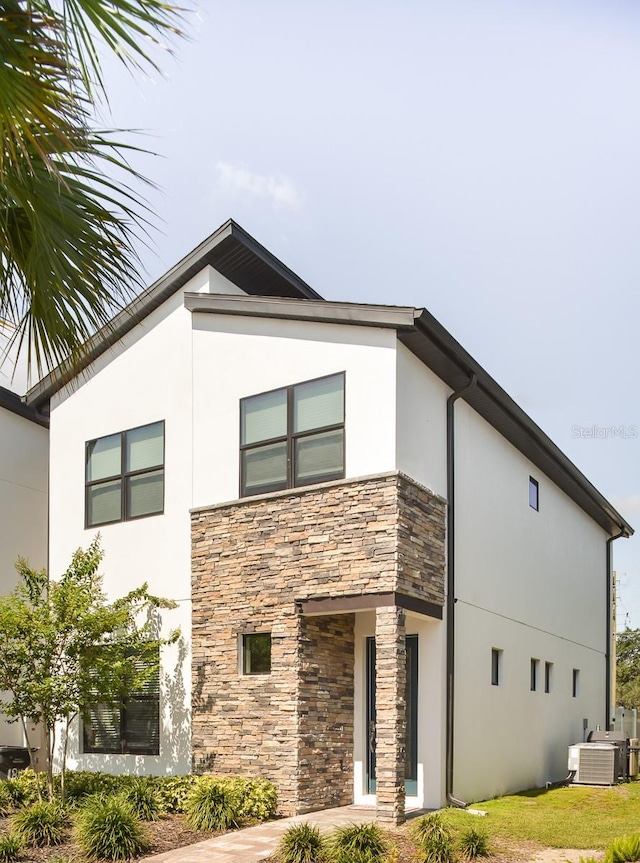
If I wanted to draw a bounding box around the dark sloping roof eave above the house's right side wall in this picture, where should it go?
[398,309,634,537]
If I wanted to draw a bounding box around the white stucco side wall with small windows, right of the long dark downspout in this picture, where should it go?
[454,403,606,800]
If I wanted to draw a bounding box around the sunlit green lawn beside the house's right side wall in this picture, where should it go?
[445,782,640,849]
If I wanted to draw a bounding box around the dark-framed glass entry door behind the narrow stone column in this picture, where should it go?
[366,635,418,796]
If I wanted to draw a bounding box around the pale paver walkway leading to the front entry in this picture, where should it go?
[141,806,376,863]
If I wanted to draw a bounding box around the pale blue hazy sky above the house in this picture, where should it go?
[87,0,640,628]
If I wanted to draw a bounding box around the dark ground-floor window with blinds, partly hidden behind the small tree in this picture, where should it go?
[82,659,160,755]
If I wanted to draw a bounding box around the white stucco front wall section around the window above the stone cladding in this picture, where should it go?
[193,314,396,506]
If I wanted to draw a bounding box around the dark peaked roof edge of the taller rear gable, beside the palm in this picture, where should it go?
[25,219,322,407]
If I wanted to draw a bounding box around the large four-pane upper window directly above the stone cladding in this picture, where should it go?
[240,373,344,497]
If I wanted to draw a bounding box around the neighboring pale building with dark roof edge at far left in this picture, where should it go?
[0,386,49,746]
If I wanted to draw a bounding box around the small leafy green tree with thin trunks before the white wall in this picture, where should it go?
[0,537,179,800]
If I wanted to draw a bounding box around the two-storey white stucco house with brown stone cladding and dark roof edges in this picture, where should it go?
[28,222,632,820]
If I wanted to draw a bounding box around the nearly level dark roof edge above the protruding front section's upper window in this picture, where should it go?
[184,292,415,329]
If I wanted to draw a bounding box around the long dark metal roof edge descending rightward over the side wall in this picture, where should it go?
[408,309,634,537]
